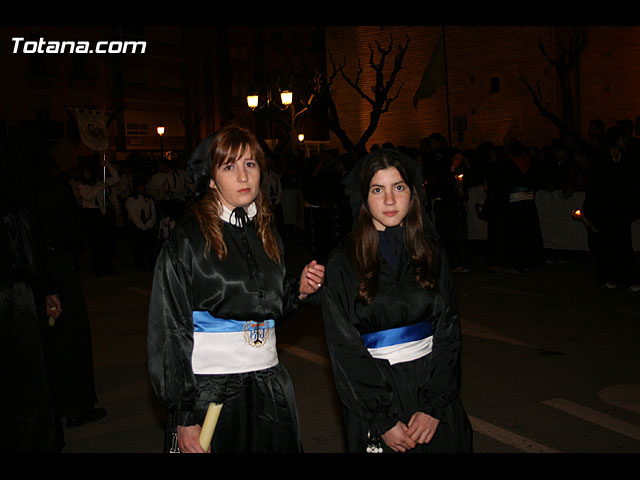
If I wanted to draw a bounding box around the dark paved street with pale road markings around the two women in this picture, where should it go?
[64,238,640,453]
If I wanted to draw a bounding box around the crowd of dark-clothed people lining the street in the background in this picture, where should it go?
[50,117,640,289]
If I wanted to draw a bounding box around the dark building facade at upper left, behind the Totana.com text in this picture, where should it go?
[0,25,324,170]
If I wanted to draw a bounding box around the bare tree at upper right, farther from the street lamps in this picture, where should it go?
[520,28,588,140]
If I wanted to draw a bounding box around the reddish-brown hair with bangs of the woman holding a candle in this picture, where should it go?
[191,126,281,263]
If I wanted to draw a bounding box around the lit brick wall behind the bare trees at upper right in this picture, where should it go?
[326,26,640,153]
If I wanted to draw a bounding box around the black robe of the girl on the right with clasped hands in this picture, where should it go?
[322,234,472,453]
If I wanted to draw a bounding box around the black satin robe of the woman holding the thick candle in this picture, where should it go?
[148,216,301,452]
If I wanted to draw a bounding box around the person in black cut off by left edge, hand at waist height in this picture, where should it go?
[0,137,64,453]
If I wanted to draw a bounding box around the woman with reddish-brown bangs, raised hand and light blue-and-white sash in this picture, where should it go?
[148,127,324,453]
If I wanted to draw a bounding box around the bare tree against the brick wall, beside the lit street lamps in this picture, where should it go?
[296,35,409,151]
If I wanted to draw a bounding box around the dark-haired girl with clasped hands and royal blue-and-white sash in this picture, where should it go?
[322,149,472,452]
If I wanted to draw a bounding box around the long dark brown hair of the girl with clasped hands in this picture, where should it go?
[350,149,439,304]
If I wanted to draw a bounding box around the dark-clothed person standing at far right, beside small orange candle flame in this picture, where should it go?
[583,127,640,292]
